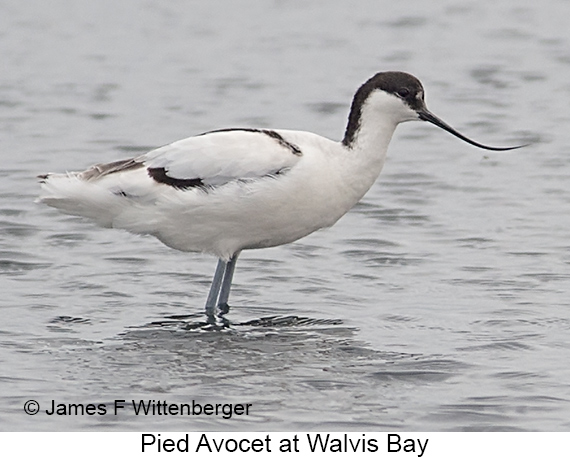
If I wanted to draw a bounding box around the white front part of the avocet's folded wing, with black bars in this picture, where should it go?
[141,129,302,188]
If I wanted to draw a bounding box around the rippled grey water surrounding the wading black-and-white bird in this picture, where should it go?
[0,0,570,431]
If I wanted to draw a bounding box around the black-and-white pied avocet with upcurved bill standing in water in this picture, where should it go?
[38,71,525,319]
